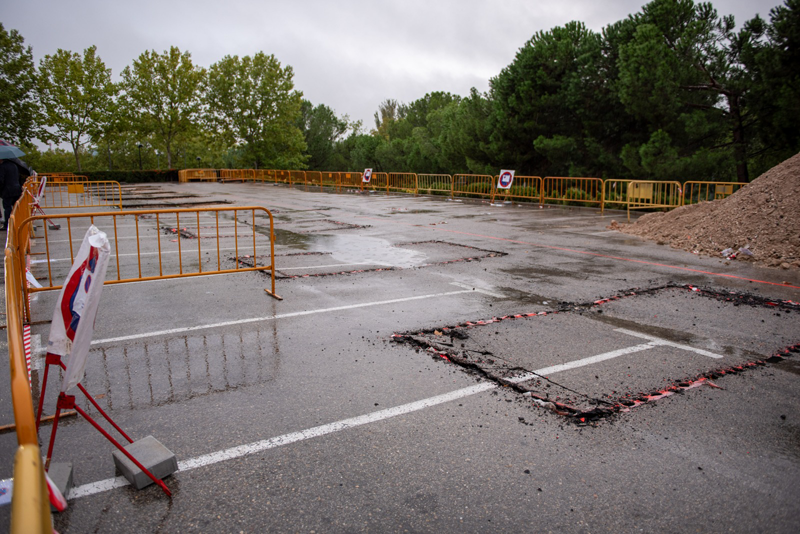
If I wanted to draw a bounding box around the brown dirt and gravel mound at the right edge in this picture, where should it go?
[609,154,800,269]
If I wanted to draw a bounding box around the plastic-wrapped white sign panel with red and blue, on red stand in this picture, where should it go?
[47,225,111,393]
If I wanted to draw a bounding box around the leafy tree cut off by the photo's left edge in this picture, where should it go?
[0,23,38,144]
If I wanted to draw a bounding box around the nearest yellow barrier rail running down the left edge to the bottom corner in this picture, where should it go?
[3,206,53,534]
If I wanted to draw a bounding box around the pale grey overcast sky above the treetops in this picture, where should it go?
[0,0,783,130]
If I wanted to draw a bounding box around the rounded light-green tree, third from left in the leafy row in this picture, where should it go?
[122,46,206,168]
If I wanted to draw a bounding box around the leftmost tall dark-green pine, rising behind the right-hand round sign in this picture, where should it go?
[490,22,607,174]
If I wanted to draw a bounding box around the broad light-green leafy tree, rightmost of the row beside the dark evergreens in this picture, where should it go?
[206,52,307,169]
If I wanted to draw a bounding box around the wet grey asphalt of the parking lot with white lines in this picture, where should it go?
[0,183,800,533]
